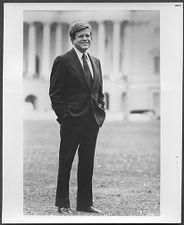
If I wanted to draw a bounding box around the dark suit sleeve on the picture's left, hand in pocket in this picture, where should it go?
[49,56,68,119]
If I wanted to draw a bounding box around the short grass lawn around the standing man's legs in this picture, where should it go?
[24,120,160,216]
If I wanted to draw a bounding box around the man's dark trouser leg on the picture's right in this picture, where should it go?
[77,114,99,209]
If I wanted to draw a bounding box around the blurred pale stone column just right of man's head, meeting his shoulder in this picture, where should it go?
[98,21,105,71]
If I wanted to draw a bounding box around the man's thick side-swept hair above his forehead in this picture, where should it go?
[69,21,92,40]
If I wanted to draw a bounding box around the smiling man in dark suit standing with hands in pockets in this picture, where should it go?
[49,22,105,213]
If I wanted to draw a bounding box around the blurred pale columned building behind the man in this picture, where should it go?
[23,10,160,120]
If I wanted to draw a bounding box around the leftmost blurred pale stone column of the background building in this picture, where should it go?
[27,23,36,78]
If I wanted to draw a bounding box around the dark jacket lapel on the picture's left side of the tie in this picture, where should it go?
[69,49,90,88]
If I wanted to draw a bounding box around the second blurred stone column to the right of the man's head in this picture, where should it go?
[111,21,121,80]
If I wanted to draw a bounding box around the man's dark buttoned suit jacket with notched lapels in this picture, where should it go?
[49,49,105,126]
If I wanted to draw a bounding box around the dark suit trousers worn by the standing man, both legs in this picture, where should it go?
[55,110,99,208]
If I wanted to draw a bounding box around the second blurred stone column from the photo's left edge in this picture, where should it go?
[41,22,51,80]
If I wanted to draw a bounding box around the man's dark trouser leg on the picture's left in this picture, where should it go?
[55,118,81,208]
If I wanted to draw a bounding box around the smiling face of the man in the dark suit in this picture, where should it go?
[72,28,92,52]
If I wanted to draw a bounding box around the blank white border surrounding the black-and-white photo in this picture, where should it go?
[2,2,183,223]
